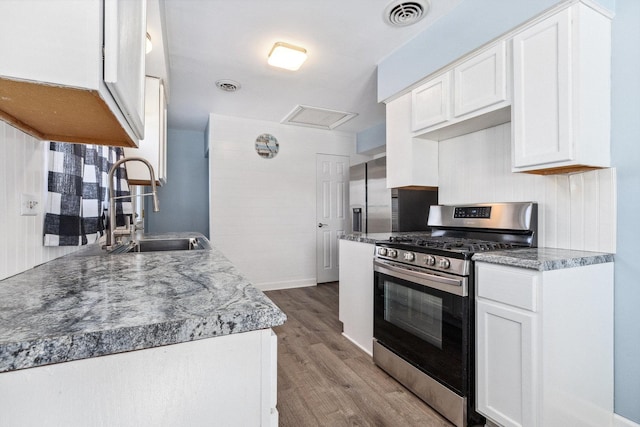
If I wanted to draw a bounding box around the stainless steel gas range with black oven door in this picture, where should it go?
[373,202,538,427]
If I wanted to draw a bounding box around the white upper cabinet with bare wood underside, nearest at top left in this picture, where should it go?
[0,0,146,147]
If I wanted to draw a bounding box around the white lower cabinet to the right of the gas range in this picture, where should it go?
[476,262,613,427]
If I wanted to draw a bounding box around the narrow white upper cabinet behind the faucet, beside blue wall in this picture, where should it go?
[124,76,167,185]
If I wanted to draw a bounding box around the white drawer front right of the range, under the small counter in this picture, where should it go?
[476,262,540,311]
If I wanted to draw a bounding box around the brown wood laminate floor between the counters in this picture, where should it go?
[265,283,452,427]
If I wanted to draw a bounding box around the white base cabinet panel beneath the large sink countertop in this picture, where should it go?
[0,329,278,427]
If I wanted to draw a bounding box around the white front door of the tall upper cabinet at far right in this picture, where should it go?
[512,9,574,167]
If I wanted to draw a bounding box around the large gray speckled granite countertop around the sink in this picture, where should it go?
[0,233,286,372]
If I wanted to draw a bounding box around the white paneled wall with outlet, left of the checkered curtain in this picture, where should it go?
[0,121,77,279]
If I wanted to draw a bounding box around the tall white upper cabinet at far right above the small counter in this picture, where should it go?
[512,3,611,173]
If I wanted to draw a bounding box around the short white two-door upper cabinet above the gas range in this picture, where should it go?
[411,40,511,140]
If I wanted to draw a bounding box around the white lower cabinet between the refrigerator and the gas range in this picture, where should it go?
[338,239,375,355]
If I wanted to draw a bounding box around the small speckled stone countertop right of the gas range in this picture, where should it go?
[473,248,613,271]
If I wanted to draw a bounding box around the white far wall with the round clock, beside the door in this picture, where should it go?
[209,114,370,289]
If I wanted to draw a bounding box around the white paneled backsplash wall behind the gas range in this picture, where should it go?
[438,123,616,252]
